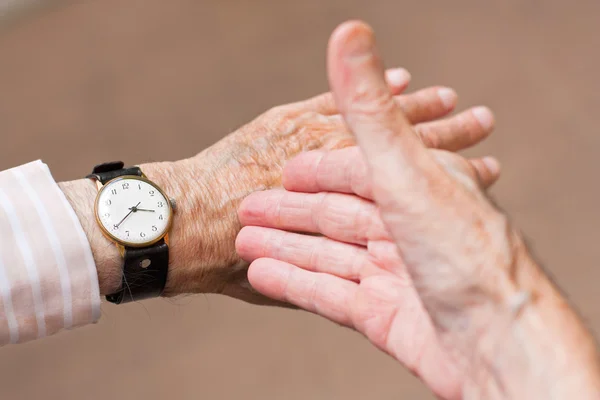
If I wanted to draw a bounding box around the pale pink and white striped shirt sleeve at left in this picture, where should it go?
[0,160,100,345]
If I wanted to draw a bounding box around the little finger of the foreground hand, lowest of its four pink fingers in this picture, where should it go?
[248,258,358,327]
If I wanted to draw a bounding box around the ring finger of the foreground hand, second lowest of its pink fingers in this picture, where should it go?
[235,226,375,281]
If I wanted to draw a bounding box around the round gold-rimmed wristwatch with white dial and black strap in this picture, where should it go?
[87,161,175,304]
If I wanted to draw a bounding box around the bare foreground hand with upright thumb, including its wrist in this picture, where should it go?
[237,23,599,398]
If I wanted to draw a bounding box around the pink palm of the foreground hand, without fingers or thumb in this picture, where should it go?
[348,242,461,398]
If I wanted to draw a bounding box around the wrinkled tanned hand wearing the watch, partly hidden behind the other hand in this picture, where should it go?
[159,69,493,304]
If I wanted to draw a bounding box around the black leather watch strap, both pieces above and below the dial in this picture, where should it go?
[87,161,169,304]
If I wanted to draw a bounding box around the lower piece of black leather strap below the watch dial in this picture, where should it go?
[106,240,169,304]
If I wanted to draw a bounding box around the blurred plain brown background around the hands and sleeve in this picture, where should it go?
[0,0,600,400]
